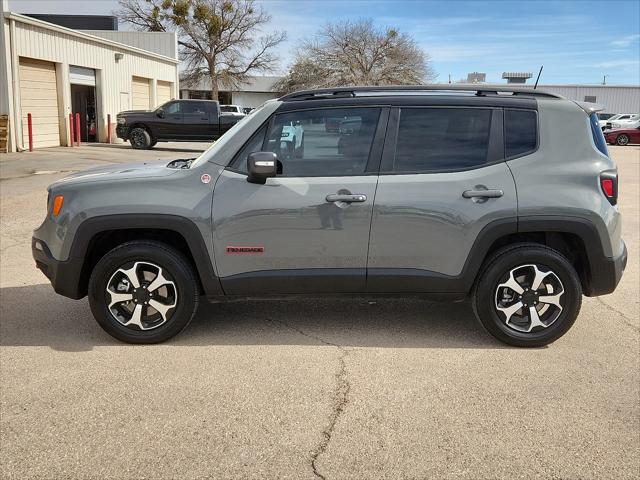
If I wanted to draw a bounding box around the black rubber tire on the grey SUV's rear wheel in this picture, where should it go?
[471,243,582,347]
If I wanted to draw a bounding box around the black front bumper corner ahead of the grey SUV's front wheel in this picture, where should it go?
[31,237,87,300]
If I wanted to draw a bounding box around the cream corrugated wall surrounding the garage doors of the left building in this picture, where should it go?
[12,16,178,148]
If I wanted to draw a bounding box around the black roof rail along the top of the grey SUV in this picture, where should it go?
[278,84,564,102]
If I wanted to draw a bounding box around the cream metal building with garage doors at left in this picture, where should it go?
[0,4,179,151]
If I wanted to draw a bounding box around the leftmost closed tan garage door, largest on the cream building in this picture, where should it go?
[19,58,60,148]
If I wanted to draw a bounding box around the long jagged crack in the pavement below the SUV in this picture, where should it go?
[221,309,351,480]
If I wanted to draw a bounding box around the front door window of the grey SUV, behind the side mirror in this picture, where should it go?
[264,107,380,177]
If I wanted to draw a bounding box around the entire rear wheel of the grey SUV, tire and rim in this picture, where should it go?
[472,244,582,347]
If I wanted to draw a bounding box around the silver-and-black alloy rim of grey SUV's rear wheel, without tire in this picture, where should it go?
[495,264,564,333]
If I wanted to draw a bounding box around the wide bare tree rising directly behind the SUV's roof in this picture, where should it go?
[276,19,436,92]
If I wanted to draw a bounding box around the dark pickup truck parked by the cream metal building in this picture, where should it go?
[116,100,243,149]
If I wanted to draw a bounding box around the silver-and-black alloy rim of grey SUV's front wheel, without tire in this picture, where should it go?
[105,262,178,330]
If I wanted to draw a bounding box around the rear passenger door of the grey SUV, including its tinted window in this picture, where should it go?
[367,107,517,292]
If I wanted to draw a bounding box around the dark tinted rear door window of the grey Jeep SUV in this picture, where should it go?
[394,108,491,173]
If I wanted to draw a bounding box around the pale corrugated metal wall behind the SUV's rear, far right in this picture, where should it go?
[539,85,640,113]
